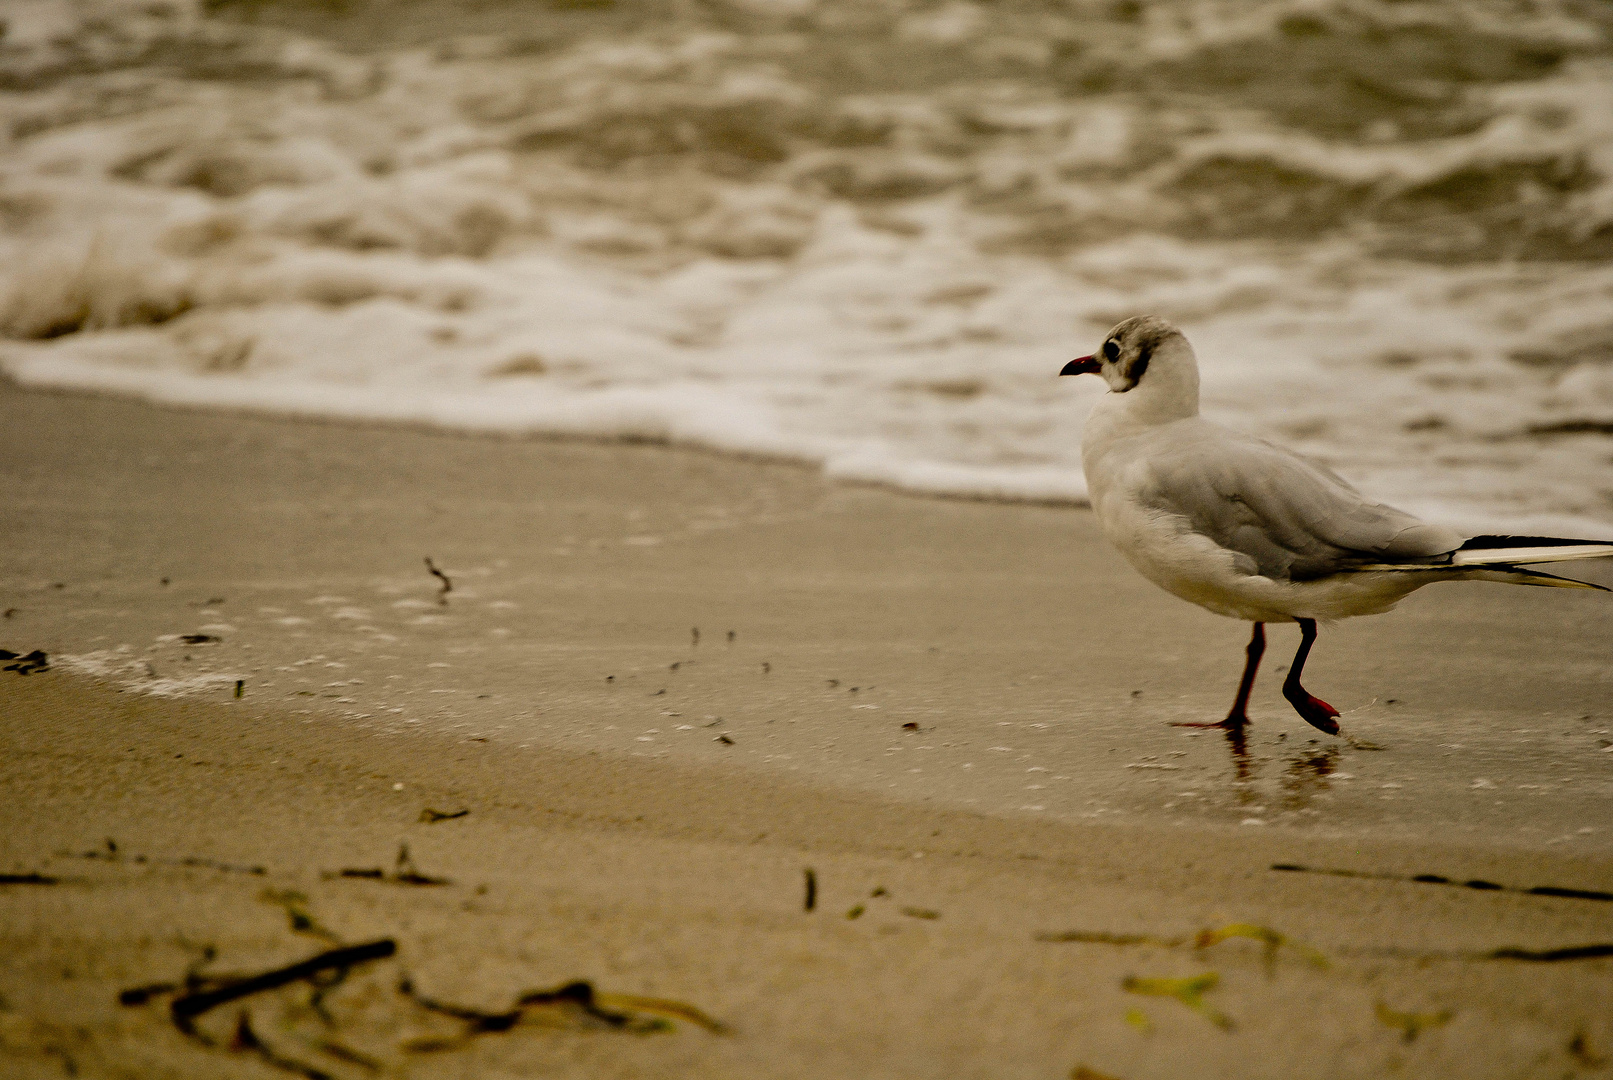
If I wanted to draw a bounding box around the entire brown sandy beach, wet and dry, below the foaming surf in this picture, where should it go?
[0,384,1613,1080]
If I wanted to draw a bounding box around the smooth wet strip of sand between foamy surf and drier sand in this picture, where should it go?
[0,380,1613,851]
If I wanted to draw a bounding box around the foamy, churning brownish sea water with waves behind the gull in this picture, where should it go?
[0,0,1613,535]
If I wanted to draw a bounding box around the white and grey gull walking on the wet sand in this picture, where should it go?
[1058,316,1613,735]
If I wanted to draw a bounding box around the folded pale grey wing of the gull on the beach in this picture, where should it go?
[1140,426,1461,580]
